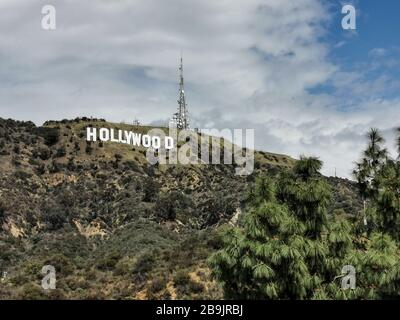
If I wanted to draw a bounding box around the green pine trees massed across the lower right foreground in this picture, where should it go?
[210,129,400,299]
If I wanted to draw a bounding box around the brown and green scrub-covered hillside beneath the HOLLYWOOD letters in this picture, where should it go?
[0,118,360,299]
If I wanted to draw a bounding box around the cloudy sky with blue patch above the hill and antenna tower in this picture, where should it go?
[0,0,400,178]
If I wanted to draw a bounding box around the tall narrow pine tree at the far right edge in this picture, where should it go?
[348,129,400,299]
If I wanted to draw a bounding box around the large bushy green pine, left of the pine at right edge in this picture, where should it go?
[210,157,330,299]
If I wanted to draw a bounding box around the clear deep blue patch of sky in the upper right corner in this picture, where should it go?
[311,0,400,99]
